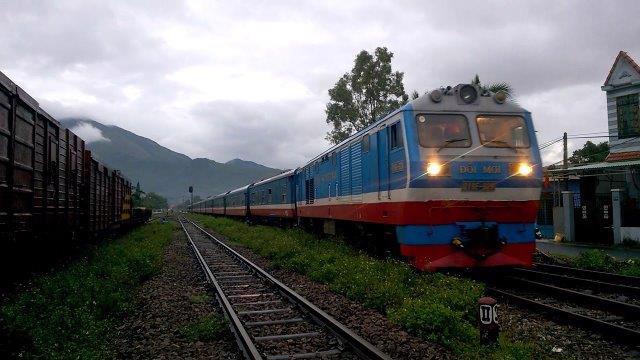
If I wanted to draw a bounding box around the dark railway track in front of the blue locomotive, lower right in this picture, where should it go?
[488,264,640,345]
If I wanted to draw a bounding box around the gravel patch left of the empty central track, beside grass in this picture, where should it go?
[114,226,242,359]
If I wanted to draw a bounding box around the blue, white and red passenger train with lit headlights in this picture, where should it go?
[192,84,542,271]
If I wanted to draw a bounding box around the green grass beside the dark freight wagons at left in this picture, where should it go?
[0,222,176,359]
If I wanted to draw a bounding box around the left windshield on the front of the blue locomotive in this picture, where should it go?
[416,114,471,149]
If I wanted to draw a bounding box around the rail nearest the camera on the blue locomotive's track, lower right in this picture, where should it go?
[487,288,640,344]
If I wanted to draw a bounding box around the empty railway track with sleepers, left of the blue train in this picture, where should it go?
[180,219,390,360]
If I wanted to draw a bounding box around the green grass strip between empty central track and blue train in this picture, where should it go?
[192,215,537,359]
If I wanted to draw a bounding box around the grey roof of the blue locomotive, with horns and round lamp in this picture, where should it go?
[300,84,527,168]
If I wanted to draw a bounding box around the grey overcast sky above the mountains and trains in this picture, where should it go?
[0,0,640,168]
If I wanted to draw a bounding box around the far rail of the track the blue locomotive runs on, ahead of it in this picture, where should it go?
[506,276,640,319]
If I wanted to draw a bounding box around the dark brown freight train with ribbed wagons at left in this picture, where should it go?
[0,72,150,268]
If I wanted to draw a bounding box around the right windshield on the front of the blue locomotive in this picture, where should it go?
[476,115,529,148]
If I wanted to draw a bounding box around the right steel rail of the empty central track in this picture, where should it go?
[183,219,391,360]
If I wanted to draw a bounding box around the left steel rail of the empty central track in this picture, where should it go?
[180,221,263,360]
